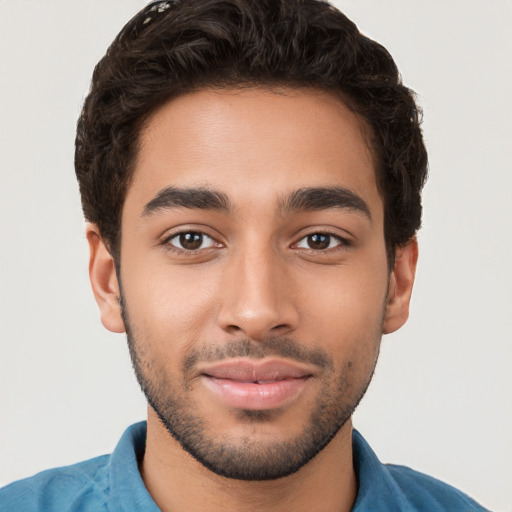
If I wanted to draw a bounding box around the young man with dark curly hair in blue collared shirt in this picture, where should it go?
[0,0,492,511]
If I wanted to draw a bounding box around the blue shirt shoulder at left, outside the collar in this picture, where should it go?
[0,455,110,512]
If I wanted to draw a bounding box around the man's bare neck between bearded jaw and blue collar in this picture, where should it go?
[140,408,357,512]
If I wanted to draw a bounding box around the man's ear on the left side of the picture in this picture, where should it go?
[85,224,125,332]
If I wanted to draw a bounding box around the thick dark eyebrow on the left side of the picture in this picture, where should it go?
[142,187,232,217]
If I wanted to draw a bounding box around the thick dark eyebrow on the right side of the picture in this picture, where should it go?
[280,187,372,220]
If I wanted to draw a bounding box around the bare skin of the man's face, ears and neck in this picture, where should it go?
[87,89,417,512]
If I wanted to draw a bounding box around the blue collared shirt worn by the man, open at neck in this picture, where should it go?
[0,422,485,512]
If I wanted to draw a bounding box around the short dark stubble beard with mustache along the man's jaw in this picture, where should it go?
[120,300,380,481]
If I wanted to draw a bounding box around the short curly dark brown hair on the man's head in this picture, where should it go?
[75,0,427,262]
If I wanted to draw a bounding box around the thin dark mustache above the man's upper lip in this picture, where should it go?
[183,337,333,374]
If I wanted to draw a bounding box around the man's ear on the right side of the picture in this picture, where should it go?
[382,238,418,334]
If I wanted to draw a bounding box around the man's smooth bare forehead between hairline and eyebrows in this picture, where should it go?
[125,88,380,216]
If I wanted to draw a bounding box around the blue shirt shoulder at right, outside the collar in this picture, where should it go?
[385,464,486,512]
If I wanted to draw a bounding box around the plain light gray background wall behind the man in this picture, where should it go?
[0,0,512,511]
